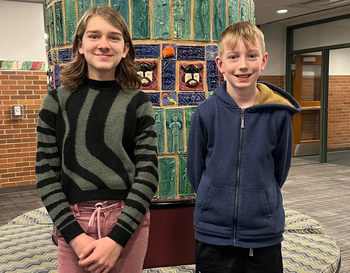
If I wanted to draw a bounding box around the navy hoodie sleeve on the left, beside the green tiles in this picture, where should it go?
[187,108,207,193]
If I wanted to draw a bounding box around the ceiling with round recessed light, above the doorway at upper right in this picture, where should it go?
[0,0,350,25]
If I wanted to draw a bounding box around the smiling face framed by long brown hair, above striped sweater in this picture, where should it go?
[78,15,129,80]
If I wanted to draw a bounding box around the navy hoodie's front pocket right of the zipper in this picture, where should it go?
[237,190,275,236]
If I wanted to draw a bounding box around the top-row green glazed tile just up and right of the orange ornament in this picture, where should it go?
[173,0,191,40]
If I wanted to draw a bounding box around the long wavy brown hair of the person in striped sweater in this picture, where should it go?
[60,6,141,92]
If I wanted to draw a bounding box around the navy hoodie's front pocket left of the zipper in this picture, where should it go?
[194,187,234,234]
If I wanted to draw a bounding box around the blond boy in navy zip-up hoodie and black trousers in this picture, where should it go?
[187,22,300,273]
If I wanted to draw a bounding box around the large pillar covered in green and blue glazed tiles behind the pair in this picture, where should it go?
[46,0,255,200]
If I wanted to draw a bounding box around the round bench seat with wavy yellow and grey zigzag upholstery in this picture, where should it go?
[0,208,340,273]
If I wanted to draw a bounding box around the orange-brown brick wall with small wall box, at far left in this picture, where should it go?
[0,71,47,188]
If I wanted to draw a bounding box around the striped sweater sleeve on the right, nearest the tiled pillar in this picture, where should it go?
[108,94,158,247]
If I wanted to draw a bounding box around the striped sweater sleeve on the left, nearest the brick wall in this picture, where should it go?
[35,91,84,243]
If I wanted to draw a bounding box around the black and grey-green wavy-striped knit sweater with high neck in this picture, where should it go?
[36,79,158,247]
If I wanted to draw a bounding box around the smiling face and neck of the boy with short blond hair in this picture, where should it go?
[216,39,268,94]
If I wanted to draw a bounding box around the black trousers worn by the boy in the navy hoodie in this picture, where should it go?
[196,240,283,273]
